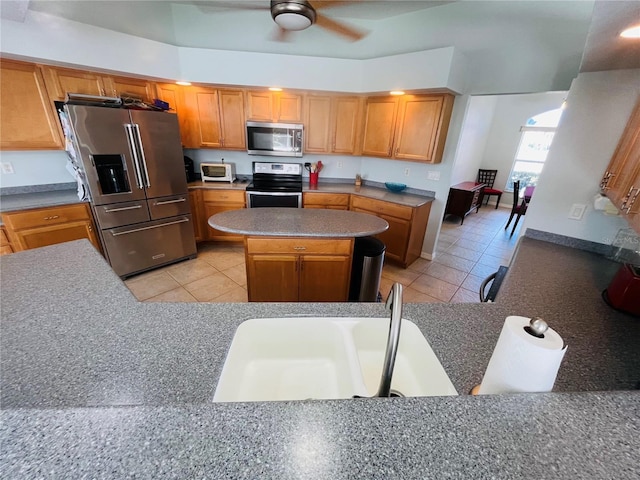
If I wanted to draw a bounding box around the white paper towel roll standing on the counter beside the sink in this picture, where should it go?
[478,316,567,395]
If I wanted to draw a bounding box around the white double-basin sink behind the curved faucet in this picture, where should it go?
[213,317,458,402]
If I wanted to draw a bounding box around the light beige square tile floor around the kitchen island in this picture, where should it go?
[125,206,518,303]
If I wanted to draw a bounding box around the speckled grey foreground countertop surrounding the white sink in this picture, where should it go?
[0,239,640,480]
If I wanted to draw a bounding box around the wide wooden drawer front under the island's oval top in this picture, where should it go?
[246,237,353,255]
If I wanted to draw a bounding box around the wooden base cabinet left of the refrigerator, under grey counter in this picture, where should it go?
[2,203,101,252]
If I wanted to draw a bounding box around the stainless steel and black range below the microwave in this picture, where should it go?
[246,162,302,208]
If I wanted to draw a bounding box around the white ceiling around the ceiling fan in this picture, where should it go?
[1,0,640,71]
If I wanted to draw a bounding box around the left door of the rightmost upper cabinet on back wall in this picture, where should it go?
[362,97,398,157]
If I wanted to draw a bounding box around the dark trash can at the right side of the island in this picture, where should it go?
[349,237,386,302]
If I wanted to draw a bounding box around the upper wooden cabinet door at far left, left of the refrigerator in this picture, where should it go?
[0,60,63,150]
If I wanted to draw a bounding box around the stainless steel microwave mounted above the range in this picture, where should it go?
[247,122,303,157]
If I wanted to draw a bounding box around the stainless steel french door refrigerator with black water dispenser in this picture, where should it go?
[64,104,196,278]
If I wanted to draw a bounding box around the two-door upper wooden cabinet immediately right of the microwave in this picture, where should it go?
[304,95,362,155]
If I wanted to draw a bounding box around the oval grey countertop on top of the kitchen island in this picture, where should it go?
[209,207,389,238]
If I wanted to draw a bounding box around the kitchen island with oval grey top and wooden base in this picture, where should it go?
[209,208,389,302]
